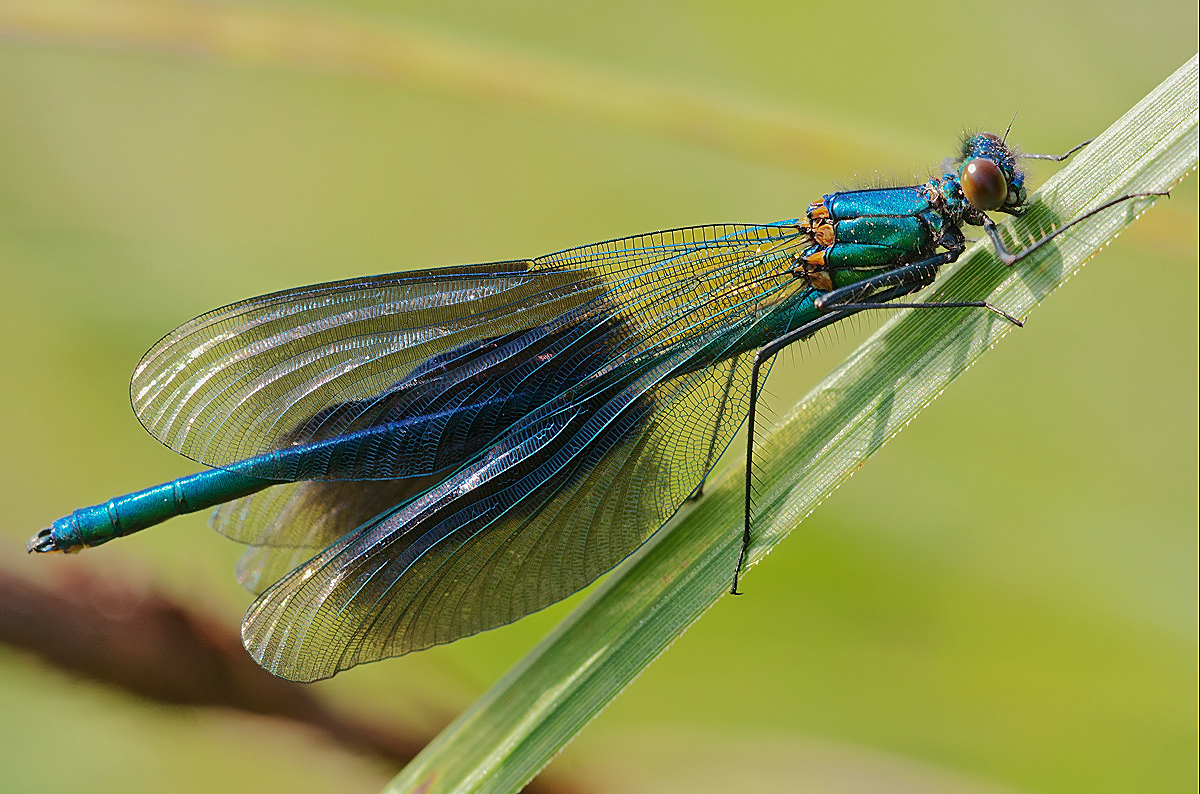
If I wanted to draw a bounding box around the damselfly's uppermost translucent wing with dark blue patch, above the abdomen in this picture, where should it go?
[131,222,805,481]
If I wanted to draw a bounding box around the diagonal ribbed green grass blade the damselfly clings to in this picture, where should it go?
[388,58,1198,792]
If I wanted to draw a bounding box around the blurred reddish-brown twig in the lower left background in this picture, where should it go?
[0,567,578,794]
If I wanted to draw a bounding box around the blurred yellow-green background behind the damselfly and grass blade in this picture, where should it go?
[0,0,1198,793]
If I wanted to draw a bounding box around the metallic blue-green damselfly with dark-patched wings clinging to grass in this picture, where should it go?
[29,133,1158,680]
